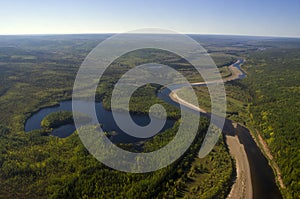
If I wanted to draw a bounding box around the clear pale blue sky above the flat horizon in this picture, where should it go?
[0,0,300,37]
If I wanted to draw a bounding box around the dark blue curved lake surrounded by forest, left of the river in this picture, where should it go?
[25,100,175,143]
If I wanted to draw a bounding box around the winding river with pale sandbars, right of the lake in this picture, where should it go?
[158,59,282,199]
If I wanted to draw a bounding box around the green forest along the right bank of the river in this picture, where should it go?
[243,46,300,198]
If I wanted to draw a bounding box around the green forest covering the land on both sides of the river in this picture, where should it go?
[0,35,300,198]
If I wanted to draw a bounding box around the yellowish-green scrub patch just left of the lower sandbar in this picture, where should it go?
[183,139,234,199]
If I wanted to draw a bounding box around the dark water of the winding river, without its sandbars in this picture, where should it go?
[158,59,282,199]
